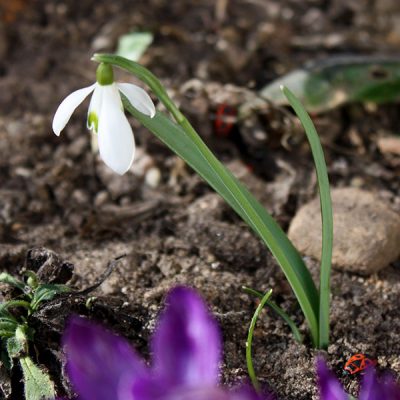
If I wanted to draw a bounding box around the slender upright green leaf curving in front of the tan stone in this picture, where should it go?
[282,87,333,348]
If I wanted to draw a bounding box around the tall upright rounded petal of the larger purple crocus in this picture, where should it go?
[152,287,221,387]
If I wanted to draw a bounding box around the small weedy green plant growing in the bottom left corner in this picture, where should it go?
[0,271,71,400]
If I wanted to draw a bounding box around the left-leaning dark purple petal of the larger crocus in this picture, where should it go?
[63,317,147,400]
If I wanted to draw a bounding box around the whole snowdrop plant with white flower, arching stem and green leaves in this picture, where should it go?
[53,54,333,348]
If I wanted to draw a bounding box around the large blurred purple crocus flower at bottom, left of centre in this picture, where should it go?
[64,287,261,400]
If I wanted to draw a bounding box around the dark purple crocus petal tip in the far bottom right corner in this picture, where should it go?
[359,368,400,400]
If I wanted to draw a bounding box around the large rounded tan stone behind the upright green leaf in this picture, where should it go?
[288,188,400,275]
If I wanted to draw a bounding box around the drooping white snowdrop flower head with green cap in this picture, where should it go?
[53,64,156,175]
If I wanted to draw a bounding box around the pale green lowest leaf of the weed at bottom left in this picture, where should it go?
[19,357,56,400]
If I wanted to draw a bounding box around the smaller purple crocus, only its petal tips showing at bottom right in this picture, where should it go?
[317,358,400,400]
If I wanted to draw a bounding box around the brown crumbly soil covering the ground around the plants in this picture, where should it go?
[0,0,400,400]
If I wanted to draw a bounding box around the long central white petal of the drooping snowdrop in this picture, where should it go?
[98,84,135,175]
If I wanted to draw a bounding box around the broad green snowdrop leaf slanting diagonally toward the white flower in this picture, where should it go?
[124,106,318,346]
